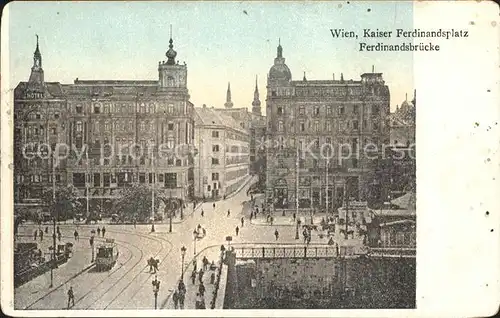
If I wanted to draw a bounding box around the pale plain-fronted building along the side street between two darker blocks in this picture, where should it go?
[194,105,250,199]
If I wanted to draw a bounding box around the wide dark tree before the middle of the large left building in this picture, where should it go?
[113,184,165,220]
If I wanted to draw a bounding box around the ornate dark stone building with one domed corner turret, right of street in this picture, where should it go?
[266,41,390,211]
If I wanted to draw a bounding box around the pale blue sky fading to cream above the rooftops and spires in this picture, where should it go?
[8,1,414,112]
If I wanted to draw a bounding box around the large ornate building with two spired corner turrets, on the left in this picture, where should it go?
[14,35,194,214]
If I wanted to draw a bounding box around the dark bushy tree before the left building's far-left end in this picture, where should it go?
[42,185,80,220]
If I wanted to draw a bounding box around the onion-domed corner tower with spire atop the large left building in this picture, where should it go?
[158,27,187,90]
